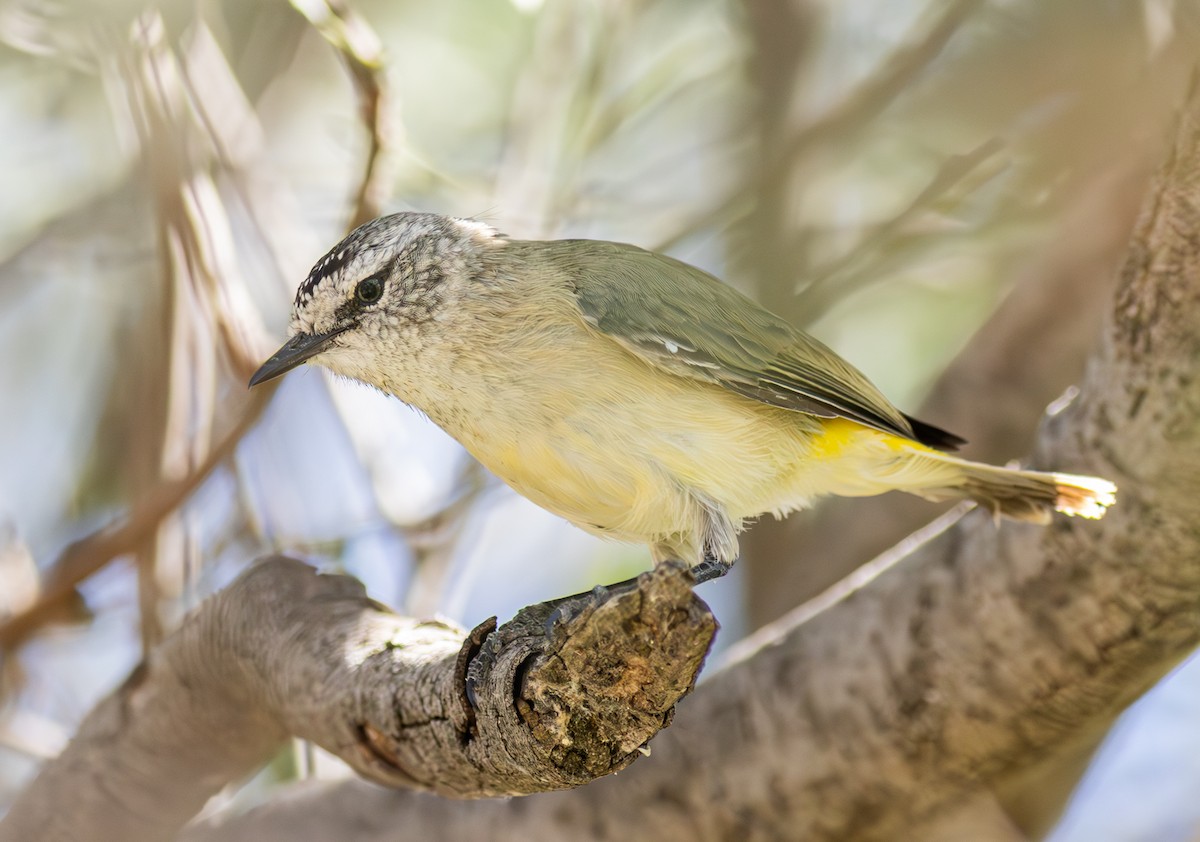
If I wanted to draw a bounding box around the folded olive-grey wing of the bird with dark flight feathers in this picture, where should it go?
[525,240,945,446]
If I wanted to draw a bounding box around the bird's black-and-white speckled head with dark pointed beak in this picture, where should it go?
[250,213,496,389]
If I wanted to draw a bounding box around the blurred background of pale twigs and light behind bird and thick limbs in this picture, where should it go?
[0,0,1200,842]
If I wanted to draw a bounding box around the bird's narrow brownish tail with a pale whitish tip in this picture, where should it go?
[905,447,1117,523]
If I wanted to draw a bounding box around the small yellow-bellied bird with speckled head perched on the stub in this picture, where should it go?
[250,213,1116,581]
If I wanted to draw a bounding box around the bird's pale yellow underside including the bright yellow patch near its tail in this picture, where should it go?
[431,326,936,563]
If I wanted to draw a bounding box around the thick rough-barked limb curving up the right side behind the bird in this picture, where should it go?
[169,77,1200,842]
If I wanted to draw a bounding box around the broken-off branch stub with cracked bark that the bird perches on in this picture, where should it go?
[0,558,716,842]
